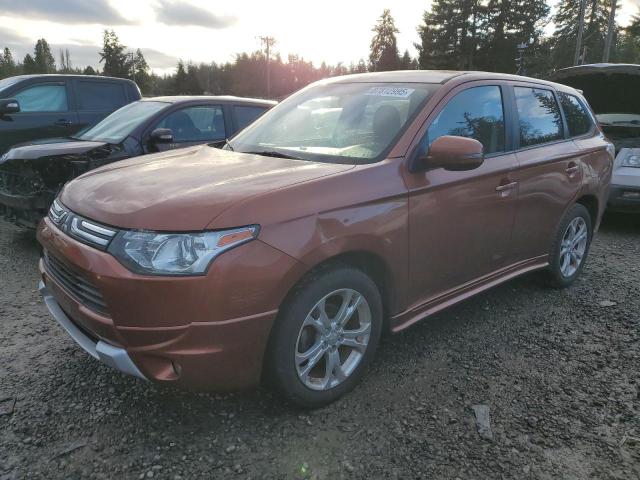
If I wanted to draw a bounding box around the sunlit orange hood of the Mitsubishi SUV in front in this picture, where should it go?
[60,146,353,231]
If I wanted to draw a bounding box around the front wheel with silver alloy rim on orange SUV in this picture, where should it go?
[267,266,383,408]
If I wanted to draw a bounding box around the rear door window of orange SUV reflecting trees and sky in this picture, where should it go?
[514,87,564,147]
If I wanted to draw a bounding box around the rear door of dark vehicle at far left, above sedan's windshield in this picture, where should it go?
[74,78,129,130]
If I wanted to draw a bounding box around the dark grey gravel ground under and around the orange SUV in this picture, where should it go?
[0,216,640,480]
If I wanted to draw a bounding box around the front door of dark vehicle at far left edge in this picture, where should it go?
[0,81,78,151]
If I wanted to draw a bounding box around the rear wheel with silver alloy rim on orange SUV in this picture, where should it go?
[546,203,593,288]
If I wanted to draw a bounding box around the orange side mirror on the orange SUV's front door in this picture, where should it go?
[409,135,484,172]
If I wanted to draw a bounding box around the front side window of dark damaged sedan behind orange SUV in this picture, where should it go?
[156,106,226,142]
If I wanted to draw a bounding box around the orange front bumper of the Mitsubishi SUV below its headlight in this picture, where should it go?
[37,217,300,391]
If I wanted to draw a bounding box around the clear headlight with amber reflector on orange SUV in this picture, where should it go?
[109,225,259,275]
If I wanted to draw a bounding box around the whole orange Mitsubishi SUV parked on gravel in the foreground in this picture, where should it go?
[38,71,613,407]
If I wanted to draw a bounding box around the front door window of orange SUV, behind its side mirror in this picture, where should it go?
[427,85,505,154]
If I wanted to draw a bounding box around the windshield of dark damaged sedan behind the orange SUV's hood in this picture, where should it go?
[73,102,169,143]
